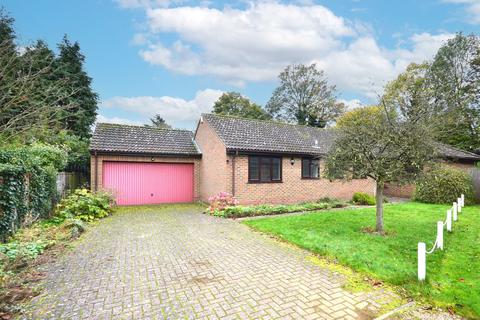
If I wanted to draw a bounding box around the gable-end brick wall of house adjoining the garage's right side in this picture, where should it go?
[195,121,231,201]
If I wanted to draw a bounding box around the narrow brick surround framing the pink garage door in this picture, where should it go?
[90,155,201,201]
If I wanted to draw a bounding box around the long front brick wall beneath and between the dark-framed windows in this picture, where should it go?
[231,156,375,204]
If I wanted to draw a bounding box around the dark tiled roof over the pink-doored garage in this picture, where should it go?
[90,123,200,155]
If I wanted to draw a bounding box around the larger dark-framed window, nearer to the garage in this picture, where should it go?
[248,156,282,182]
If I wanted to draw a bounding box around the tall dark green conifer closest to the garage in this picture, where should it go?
[55,36,98,138]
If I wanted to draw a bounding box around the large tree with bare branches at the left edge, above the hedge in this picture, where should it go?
[0,12,72,143]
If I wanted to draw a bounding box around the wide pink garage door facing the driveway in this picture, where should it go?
[103,162,193,205]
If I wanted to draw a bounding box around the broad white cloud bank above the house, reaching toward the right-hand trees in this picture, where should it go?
[124,0,454,98]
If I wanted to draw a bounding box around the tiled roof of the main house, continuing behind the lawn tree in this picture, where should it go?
[202,114,480,160]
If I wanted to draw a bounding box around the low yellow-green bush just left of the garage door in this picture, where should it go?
[56,189,115,221]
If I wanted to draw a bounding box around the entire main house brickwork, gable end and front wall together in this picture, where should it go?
[195,121,375,204]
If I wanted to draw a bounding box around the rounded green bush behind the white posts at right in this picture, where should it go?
[413,165,474,204]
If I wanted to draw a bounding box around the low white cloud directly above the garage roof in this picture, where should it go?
[102,89,223,129]
